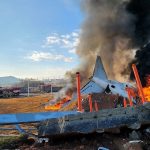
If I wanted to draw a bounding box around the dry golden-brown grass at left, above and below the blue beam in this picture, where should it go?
[0,94,53,135]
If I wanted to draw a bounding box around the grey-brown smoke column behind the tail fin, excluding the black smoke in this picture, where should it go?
[66,0,135,89]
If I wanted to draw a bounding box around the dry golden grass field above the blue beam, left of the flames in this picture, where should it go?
[0,94,52,114]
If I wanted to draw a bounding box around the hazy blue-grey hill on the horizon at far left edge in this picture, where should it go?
[0,76,21,86]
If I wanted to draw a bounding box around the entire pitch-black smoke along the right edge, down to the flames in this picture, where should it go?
[125,0,150,86]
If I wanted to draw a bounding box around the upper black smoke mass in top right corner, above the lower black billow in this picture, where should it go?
[126,0,150,47]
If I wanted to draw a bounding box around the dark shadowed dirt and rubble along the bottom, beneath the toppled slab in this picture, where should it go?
[0,128,150,150]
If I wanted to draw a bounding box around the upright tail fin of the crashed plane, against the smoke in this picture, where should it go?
[93,56,108,80]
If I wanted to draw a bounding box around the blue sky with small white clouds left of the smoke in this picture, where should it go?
[0,0,83,78]
